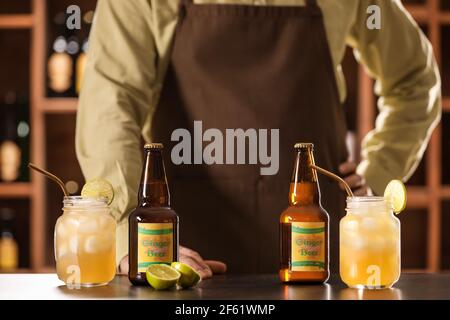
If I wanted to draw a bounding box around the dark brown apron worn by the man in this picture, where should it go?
[152,0,347,273]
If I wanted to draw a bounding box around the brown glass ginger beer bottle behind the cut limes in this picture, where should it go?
[128,143,178,285]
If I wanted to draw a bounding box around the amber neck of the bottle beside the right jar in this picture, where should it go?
[289,148,320,206]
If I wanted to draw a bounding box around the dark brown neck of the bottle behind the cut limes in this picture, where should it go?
[138,150,170,207]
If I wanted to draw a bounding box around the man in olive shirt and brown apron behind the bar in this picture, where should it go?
[76,0,441,278]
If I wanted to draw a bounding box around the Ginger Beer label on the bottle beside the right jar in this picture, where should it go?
[291,222,326,271]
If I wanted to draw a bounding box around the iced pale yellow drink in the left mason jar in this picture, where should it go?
[55,197,116,286]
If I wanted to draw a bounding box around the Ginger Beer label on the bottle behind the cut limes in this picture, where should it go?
[137,223,173,272]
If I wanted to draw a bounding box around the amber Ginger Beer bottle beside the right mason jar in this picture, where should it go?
[279,143,329,283]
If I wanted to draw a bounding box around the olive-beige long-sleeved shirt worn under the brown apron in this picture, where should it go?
[76,0,441,261]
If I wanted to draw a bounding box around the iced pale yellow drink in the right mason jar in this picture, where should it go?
[340,197,400,289]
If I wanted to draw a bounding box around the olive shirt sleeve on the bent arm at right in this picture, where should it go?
[347,0,442,194]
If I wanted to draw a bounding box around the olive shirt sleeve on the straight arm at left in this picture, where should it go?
[76,0,157,263]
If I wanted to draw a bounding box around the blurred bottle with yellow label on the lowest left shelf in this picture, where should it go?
[0,208,19,271]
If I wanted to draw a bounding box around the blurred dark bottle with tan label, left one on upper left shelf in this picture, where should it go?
[47,12,74,97]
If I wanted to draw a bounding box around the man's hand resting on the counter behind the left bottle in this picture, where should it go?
[117,246,227,279]
